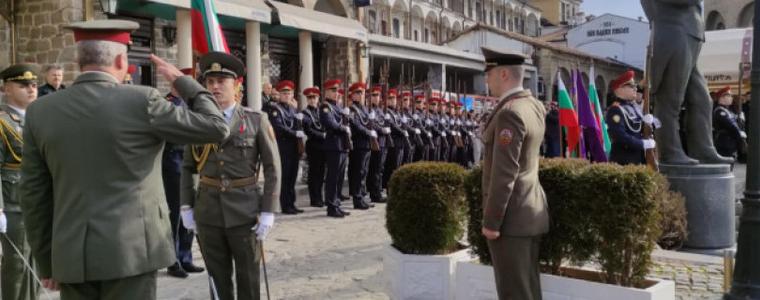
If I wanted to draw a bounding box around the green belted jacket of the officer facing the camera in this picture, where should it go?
[180,105,281,228]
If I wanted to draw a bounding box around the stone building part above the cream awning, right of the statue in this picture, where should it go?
[704,0,755,30]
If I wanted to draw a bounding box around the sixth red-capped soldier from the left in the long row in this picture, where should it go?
[382,89,411,189]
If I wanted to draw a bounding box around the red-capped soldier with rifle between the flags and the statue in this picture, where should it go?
[605,71,655,165]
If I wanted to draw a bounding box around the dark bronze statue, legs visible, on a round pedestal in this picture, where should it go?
[641,0,733,165]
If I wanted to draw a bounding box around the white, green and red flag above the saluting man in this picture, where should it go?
[190,0,230,55]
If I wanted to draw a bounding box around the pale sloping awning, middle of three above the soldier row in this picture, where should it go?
[269,1,367,42]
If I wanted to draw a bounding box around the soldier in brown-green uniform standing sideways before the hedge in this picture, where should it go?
[482,48,549,300]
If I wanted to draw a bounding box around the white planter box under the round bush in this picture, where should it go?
[383,245,472,300]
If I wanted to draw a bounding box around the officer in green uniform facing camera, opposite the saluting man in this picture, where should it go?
[180,52,280,300]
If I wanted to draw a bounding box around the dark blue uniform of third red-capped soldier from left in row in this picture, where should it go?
[319,98,348,216]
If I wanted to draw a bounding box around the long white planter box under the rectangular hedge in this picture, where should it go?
[456,261,676,300]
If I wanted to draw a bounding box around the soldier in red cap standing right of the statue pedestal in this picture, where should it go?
[713,87,747,157]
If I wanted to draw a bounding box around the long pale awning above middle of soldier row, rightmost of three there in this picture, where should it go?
[369,34,485,71]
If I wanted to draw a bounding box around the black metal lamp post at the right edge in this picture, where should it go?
[725,0,760,299]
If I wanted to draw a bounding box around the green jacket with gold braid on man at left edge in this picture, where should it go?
[0,104,24,212]
